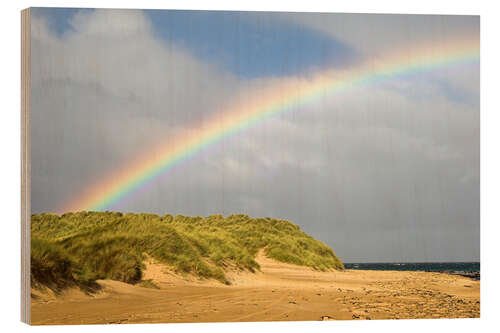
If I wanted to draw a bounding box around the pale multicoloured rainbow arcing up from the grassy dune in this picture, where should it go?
[59,38,479,213]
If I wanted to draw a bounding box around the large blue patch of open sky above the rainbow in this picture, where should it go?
[145,10,356,78]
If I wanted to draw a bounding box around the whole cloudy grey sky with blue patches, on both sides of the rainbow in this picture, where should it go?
[31,8,479,262]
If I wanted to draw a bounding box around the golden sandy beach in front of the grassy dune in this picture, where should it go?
[31,253,480,325]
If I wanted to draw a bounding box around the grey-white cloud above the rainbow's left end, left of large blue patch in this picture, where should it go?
[31,10,242,211]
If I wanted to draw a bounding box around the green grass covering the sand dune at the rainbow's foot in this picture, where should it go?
[31,212,343,289]
